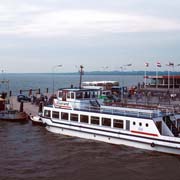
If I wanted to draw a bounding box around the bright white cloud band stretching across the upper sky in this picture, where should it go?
[0,4,180,37]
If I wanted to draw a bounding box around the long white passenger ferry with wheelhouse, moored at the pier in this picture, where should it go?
[42,89,180,155]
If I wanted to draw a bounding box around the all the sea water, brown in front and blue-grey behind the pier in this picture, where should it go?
[0,74,180,180]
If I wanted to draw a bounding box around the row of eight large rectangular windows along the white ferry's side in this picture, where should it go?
[44,110,124,129]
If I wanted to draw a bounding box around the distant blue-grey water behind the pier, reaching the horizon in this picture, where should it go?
[3,74,143,94]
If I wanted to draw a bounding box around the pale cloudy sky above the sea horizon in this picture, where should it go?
[0,0,180,73]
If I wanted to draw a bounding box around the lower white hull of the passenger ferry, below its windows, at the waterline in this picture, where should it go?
[43,120,180,155]
